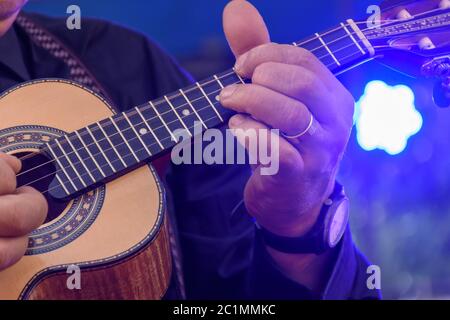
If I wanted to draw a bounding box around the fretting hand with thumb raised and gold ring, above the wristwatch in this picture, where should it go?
[220,0,354,290]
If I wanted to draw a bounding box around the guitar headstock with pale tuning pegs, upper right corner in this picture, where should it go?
[362,0,450,107]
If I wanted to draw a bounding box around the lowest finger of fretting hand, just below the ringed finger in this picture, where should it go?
[229,114,304,175]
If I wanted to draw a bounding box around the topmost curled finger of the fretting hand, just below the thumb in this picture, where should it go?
[235,43,335,86]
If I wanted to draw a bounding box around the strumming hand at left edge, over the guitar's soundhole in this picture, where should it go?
[0,153,47,270]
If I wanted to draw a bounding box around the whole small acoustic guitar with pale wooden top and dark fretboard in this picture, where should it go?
[0,0,450,299]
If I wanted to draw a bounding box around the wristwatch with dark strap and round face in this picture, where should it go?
[255,183,349,254]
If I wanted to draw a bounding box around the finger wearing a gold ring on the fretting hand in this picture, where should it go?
[220,84,311,136]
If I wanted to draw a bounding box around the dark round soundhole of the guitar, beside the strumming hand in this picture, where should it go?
[15,152,69,223]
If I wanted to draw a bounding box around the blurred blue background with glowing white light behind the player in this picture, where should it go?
[26,0,450,299]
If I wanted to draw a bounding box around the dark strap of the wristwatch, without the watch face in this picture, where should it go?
[255,182,343,254]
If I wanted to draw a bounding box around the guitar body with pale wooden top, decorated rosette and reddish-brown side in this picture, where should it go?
[0,80,171,299]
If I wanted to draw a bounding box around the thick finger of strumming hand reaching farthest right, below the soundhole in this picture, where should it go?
[0,187,48,237]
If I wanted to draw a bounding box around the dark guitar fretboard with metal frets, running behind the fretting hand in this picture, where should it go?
[44,20,374,199]
